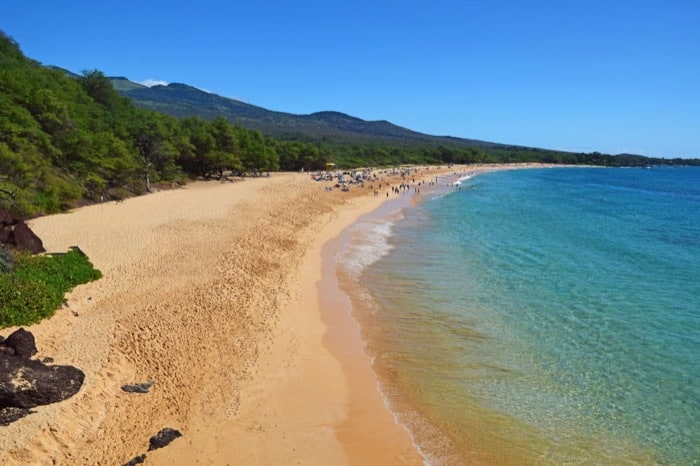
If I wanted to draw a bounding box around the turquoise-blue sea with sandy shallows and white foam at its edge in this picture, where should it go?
[339,167,700,465]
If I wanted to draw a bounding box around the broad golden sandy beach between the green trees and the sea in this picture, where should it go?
[0,166,536,465]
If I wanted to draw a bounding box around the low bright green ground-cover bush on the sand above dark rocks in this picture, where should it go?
[0,247,102,328]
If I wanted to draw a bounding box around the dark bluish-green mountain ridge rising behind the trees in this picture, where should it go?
[109,77,498,147]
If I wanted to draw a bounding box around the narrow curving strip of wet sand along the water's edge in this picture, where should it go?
[318,164,564,465]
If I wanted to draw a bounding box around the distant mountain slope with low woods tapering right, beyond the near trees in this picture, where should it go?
[110,78,697,166]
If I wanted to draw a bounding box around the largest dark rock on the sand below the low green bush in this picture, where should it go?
[0,352,85,409]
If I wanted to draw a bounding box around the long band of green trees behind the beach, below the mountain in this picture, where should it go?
[0,31,696,217]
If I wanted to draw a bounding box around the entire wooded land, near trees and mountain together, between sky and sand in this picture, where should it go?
[0,31,700,217]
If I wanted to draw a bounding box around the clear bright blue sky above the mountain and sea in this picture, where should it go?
[0,0,700,157]
